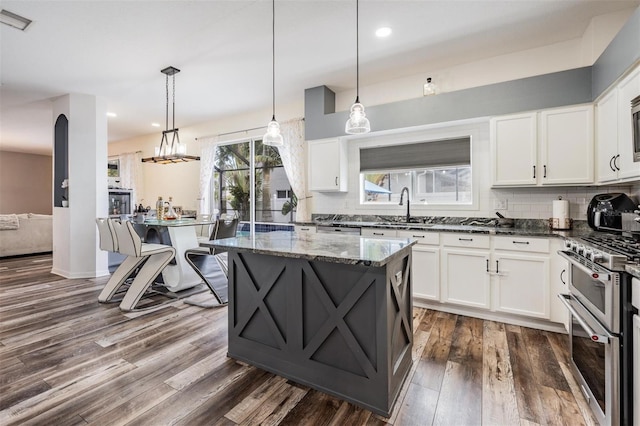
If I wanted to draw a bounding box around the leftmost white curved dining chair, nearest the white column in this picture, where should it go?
[96,217,145,303]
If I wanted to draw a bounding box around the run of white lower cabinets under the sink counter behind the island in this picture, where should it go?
[361,228,568,327]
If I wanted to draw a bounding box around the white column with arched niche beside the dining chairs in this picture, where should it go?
[51,94,109,278]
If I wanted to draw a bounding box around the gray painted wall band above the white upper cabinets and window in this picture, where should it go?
[305,8,640,140]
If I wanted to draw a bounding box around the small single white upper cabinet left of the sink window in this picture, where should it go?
[307,138,348,192]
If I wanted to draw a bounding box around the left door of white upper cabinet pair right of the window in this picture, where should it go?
[490,112,538,186]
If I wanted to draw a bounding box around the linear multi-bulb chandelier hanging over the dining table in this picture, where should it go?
[142,67,200,164]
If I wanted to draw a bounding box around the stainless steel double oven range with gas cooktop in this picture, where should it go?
[558,233,640,426]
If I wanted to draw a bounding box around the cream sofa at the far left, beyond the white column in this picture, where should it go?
[0,213,53,257]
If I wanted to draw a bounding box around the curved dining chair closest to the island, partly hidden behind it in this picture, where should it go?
[184,218,238,307]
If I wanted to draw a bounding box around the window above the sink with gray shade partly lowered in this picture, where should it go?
[360,137,473,205]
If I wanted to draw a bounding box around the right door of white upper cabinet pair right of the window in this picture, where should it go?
[539,105,593,185]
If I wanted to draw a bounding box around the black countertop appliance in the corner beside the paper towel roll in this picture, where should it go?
[587,192,637,231]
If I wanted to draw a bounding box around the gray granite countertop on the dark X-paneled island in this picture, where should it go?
[201,231,416,267]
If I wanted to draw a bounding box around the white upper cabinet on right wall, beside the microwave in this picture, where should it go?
[596,67,640,183]
